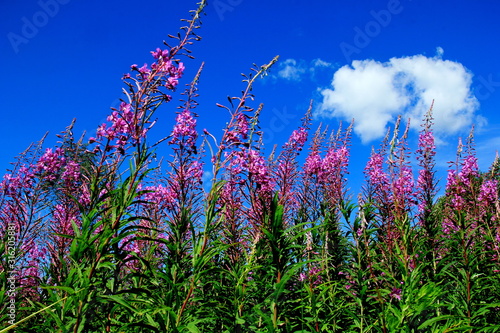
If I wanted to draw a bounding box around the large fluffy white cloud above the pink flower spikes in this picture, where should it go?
[316,52,484,143]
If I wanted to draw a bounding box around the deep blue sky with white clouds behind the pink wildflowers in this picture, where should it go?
[0,0,500,195]
